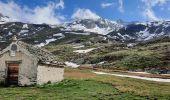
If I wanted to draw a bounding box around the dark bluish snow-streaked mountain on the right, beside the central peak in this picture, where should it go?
[108,21,170,42]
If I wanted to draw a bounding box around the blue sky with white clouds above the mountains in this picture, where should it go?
[0,0,170,24]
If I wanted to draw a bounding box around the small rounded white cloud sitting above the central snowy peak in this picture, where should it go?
[71,8,100,20]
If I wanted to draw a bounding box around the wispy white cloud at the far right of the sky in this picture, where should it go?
[141,0,168,20]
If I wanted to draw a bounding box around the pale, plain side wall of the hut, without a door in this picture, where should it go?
[37,65,64,85]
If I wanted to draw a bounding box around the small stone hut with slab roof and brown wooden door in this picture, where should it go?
[0,37,64,86]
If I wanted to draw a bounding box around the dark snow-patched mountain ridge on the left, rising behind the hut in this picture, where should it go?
[0,22,104,48]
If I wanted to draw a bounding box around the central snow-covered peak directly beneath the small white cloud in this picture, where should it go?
[65,18,123,35]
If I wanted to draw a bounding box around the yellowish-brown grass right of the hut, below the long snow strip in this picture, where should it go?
[66,69,170,100]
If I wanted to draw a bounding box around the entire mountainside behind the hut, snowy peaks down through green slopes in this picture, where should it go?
[0,15,170,70]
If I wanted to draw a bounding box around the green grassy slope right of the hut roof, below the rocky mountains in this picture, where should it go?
[46,42,170,70]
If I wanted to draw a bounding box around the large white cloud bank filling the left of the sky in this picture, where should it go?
[0,0,65,24]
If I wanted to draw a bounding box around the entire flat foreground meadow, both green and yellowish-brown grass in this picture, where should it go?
[0,68,170,100]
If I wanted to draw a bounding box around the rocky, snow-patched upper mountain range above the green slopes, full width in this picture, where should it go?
[0,14,170,48]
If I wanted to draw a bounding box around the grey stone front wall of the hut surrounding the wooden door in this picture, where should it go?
[0,51,37,86]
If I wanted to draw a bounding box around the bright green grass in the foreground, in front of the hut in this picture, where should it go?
[0,79,147,100]
